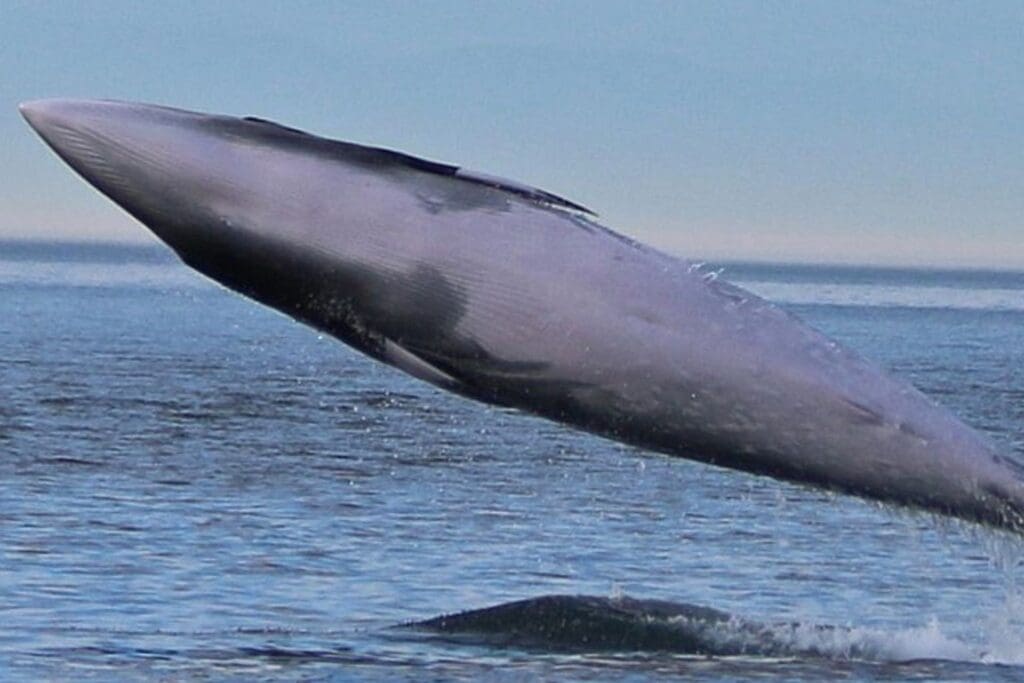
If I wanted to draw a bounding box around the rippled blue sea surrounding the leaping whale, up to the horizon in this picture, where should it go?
[0,243,1024,681]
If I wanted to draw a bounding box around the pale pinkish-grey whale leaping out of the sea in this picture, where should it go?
[22,100,1024,531]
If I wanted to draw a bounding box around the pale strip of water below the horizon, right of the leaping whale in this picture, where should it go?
[733,281,1024,310]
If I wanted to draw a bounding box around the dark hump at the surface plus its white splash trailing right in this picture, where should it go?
[396,595,1024,666]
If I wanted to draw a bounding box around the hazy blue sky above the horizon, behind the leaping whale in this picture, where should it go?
[0,0,1024,268]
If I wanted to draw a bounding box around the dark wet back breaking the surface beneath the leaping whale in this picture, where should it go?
[396,595,863,656]
